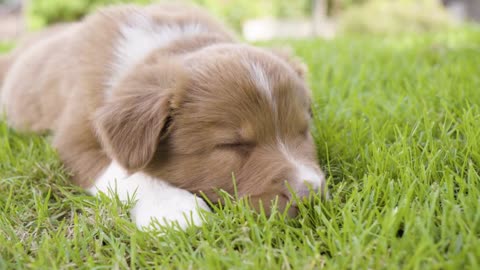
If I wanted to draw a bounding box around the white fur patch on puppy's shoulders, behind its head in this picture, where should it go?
[106,12,208,93]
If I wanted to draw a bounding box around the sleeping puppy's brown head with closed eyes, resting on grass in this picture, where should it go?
[95,45,325,214]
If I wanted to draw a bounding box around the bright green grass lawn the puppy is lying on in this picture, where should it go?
[0,29,480,269]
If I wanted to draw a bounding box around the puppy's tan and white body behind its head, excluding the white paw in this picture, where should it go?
[1,6,230,187]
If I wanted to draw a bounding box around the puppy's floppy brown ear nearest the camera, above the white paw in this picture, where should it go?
[94,65,182,171]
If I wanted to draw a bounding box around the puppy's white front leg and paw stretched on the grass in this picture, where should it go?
[88,161,210,229]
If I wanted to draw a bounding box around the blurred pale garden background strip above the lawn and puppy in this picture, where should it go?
[0,0,480,42]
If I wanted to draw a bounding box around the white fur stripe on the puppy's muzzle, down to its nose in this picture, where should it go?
[278,141,325,189]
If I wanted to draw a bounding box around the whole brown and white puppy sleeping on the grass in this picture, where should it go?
[0,5,324,228]
